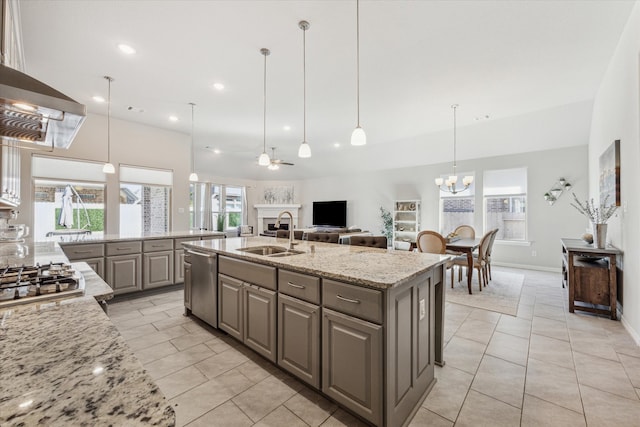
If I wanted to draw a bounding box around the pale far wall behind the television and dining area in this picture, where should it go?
[301,145,588,271]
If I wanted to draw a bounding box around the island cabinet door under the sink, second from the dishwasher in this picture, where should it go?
[243,283,277,363]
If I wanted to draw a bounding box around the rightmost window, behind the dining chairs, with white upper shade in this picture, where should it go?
[483,168,527,241]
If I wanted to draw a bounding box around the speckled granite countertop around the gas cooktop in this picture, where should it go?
[0,242,175,427]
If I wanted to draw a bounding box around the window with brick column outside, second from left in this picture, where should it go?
[120,166,173,235]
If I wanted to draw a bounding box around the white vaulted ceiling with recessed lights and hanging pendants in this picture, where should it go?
[20,0,634,179]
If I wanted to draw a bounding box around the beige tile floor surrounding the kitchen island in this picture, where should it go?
[109,269,640,427]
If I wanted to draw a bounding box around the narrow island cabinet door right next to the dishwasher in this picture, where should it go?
[218,274,244,341]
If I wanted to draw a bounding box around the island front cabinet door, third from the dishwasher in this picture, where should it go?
[278,294,321,388]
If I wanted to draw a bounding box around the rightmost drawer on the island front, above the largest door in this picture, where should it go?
[322,279,382,323]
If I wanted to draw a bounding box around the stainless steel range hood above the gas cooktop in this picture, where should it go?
[0,65,87,148]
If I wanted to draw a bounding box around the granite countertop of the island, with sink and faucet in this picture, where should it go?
[184,237,449,289]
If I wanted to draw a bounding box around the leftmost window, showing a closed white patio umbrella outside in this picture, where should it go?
[31,155,105,241]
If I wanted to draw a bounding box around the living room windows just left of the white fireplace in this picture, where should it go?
[190,183,247,231]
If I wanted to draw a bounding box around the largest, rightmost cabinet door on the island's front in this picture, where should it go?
[322,308,383,425]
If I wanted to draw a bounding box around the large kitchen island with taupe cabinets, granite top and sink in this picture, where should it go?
[183,237,448,427]
